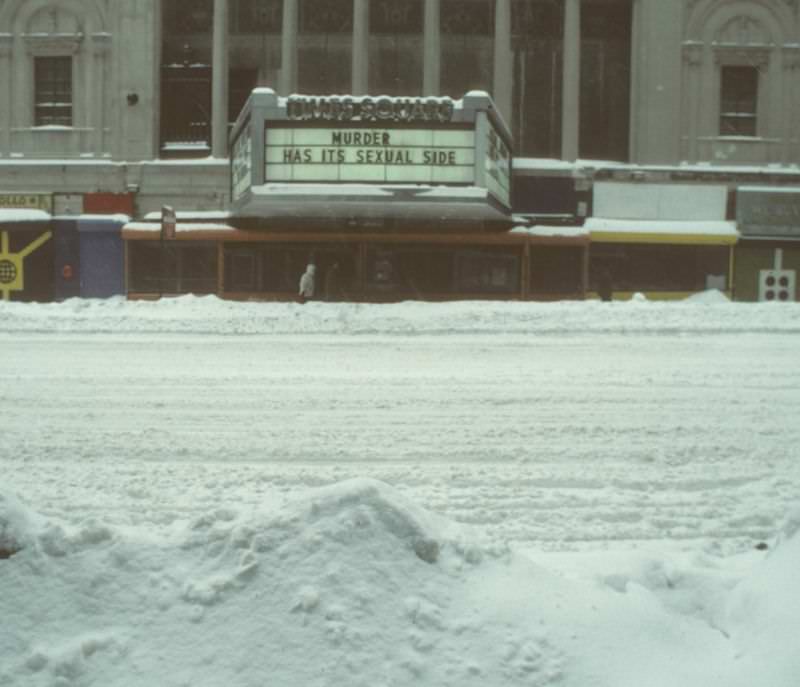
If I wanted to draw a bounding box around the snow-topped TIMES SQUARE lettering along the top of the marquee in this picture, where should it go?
[286,95,455,124]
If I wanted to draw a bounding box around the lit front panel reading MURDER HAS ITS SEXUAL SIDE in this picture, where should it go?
[264,127,475,184]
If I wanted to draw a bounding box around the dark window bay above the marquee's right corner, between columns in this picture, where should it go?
[440,0,494,98]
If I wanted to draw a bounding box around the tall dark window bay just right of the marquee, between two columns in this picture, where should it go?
[511,0,564,158]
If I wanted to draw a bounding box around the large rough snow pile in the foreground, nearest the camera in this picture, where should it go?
[0,479,800,687]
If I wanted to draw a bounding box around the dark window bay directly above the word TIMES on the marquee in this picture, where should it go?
[297,0,353,95]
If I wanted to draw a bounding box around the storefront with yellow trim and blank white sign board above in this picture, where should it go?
[584,182,738,299]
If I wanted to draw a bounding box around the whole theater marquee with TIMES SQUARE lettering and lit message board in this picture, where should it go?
[231,89,511,226]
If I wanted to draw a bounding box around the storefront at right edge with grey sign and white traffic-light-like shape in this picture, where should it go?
[734,186,800,302]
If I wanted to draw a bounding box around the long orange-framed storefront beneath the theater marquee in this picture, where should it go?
[123,218,530,302]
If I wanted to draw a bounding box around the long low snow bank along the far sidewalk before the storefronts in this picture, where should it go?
[0,292,800,335]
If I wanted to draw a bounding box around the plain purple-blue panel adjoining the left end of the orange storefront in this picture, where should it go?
[81,224,125,298]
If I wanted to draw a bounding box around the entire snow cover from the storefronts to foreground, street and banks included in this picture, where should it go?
[0,296,800,687]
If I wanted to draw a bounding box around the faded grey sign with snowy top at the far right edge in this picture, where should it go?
[736,187,800,238]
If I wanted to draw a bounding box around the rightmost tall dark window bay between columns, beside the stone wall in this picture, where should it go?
[579,0,632,161]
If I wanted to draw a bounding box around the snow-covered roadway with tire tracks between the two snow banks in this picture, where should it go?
[0,298,800,548]
